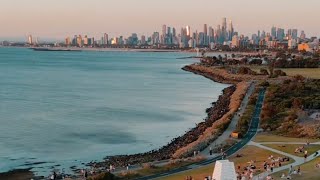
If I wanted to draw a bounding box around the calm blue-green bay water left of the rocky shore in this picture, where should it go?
[0,48,227,175]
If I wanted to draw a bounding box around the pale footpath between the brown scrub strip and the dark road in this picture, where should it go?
[200,83,256,158]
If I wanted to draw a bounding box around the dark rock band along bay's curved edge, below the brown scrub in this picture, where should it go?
[89,82,236,167]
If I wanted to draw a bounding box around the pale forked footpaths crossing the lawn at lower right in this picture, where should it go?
[248,141,319,180]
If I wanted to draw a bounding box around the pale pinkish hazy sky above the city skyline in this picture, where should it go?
[0,0,320,40]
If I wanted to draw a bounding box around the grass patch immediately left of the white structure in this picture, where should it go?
[161,164,214,180]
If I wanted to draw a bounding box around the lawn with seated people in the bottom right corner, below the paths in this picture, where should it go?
[272,157,320,180]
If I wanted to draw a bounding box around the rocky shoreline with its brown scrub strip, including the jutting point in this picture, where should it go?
[88,65,249,172]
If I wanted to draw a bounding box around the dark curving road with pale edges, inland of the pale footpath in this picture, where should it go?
[137,89,266,180]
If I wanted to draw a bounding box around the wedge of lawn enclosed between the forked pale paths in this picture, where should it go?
[263,144,320,157]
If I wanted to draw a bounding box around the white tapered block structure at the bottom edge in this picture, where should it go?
[212,160,237,180]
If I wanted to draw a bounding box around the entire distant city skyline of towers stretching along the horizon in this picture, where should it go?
[2,18,319,52]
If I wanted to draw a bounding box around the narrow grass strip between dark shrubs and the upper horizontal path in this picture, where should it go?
[253,133,319,143]
